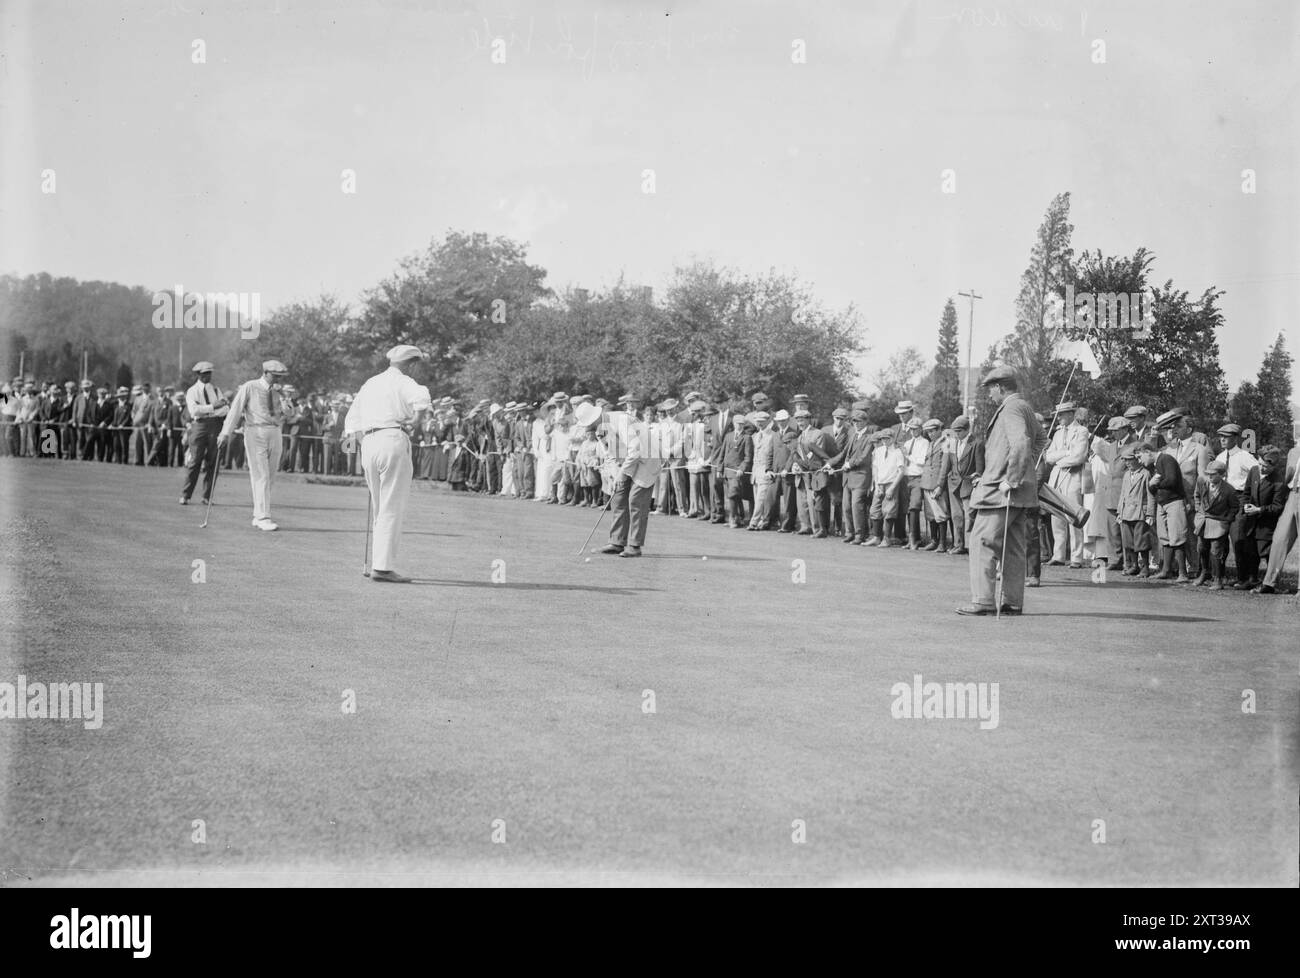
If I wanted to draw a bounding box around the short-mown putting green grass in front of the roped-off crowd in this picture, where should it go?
[0,459,1300,886]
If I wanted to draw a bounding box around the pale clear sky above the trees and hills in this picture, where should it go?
[0,0,1300,388]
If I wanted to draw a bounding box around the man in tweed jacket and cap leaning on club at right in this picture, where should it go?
[957,367,1047,615]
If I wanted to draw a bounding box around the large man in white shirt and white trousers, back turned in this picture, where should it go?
[343,345,433,584]
